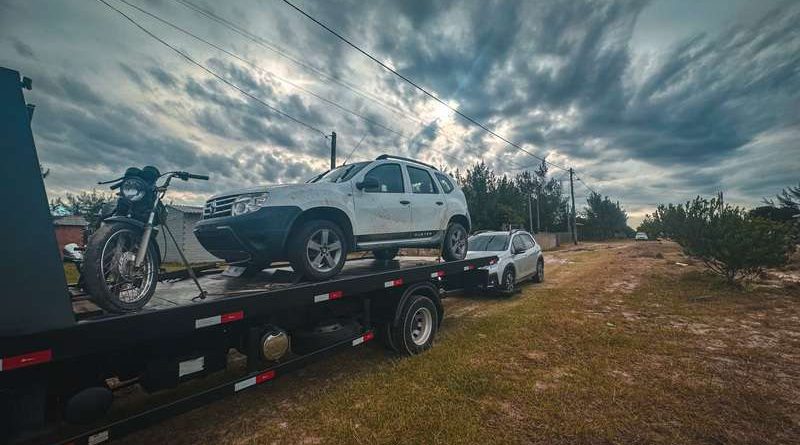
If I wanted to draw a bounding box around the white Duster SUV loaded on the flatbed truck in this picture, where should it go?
[194,155,470,280]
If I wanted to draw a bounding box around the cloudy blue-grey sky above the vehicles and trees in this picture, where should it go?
[0,0,800,226]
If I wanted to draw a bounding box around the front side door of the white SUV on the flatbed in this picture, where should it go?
[353,162,411,239]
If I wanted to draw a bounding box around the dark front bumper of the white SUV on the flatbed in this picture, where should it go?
[194,206,302,263]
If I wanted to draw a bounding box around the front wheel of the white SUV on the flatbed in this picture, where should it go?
[288,219,348,281]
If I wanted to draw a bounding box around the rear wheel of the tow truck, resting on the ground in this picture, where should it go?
[389,295,439,355]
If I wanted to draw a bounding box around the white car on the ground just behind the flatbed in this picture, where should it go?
[467,230,544,291]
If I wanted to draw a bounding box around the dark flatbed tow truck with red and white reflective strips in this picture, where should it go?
[0,68,496,445]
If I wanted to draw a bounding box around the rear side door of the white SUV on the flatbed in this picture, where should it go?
[405,165,447,238]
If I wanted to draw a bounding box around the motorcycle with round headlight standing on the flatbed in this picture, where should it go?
[81,166,208,313]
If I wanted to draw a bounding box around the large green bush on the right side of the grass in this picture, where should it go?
[642,196,794,282]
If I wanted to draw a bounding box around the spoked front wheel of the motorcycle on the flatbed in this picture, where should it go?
[83,222,160,313]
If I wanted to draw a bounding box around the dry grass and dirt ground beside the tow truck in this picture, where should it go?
[115,242,800,444]
